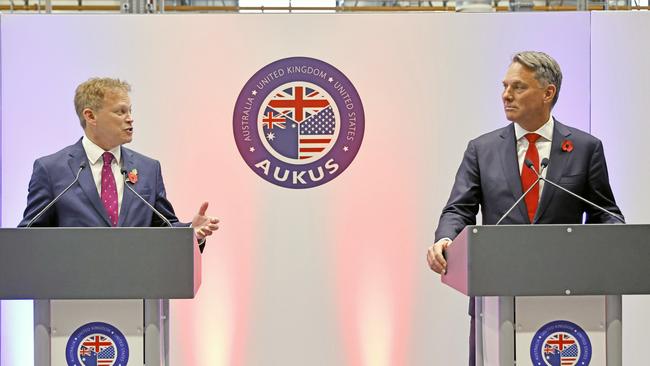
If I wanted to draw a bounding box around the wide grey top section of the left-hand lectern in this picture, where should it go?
[0,228,200,299]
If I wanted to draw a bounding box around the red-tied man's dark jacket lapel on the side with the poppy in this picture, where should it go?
[533,120,572,222]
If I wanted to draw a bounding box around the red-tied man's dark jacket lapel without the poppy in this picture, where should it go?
[500,123,530,223]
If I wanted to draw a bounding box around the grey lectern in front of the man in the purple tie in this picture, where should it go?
[0,228,201,365]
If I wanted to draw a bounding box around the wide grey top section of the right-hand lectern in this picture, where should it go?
[442,224,650,296]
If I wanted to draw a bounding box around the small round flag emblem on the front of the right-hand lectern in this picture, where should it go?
[530,320,591,366]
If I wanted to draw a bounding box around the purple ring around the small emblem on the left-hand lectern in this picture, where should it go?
[65,322,129,366]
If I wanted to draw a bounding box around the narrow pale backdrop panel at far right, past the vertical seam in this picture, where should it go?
[591,12,650,365]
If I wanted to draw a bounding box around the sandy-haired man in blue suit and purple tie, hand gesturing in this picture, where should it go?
[18,78,219,249]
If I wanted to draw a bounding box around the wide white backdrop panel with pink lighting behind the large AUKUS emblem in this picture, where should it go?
[0,13,588,366]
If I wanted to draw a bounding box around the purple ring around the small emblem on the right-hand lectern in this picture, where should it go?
[530,320,592,365]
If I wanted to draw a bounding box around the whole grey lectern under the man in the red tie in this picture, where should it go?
[442,225,650,366]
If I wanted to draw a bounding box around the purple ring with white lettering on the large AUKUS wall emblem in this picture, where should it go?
[233,57,365,189]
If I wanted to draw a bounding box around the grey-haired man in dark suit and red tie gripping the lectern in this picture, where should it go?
[427,52,621,365]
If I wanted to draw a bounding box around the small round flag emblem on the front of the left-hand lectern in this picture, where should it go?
[65,322,129,366]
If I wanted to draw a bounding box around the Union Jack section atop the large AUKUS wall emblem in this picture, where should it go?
[269,86,330,124]
